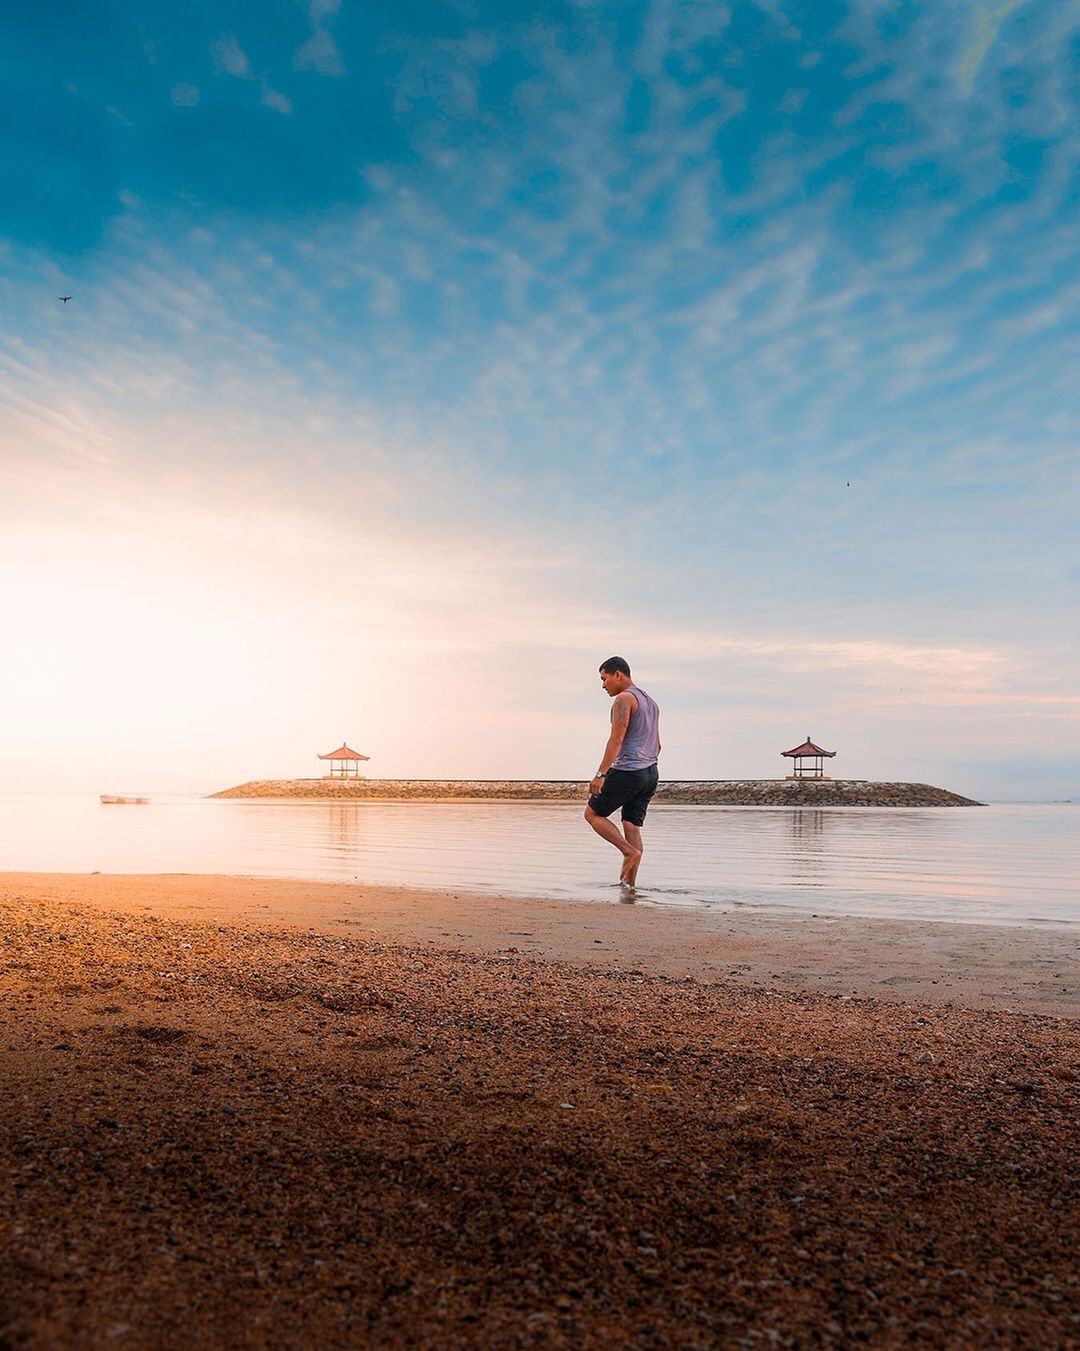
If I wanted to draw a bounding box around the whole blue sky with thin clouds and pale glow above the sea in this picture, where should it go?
[0,0,1080,798]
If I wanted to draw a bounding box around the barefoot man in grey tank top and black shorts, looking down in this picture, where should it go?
[585,657,660,886]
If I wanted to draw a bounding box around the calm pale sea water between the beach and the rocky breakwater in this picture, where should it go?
[0,794,1080,924]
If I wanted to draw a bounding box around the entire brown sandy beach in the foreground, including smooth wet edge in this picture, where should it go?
[0,874,1080,1348]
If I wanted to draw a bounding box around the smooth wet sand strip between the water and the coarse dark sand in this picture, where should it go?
[0,873,1080,1019]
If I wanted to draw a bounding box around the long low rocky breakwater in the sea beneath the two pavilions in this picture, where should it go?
[210,778,983,807]
